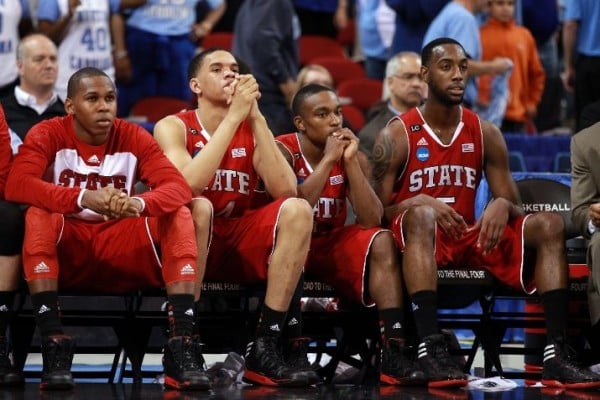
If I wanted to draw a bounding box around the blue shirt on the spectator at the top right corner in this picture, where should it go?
[565,0,600,57]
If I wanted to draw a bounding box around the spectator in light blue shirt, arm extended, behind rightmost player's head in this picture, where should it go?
[423,0,512,108]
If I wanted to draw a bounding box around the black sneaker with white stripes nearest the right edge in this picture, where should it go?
[542,340,600,389]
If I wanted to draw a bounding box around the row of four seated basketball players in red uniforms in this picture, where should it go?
[1,38,600,390]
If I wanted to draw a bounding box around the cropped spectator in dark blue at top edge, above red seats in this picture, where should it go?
[292,0,348,38]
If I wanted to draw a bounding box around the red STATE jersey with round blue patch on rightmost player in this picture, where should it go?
[392,107,483,225]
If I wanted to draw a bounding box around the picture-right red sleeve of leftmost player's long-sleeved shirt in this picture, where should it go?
[126,125,192,216]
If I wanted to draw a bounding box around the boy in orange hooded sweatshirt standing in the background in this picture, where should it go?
[478,0,544,132]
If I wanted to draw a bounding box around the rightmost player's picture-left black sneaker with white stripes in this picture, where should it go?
[417,334,468,387]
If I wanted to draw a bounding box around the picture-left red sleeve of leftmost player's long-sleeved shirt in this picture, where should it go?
[6,118,81,214]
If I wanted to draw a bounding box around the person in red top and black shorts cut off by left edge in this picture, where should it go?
[0,106,25,388]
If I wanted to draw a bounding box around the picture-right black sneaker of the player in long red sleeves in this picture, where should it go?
[162,336,210,390]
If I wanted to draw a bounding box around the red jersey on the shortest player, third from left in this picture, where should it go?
[276,133,347,234]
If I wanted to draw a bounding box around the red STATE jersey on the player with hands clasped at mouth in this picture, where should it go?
[176,110,258,217]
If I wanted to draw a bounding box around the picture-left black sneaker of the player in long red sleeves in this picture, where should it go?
[40,335,75,390]
